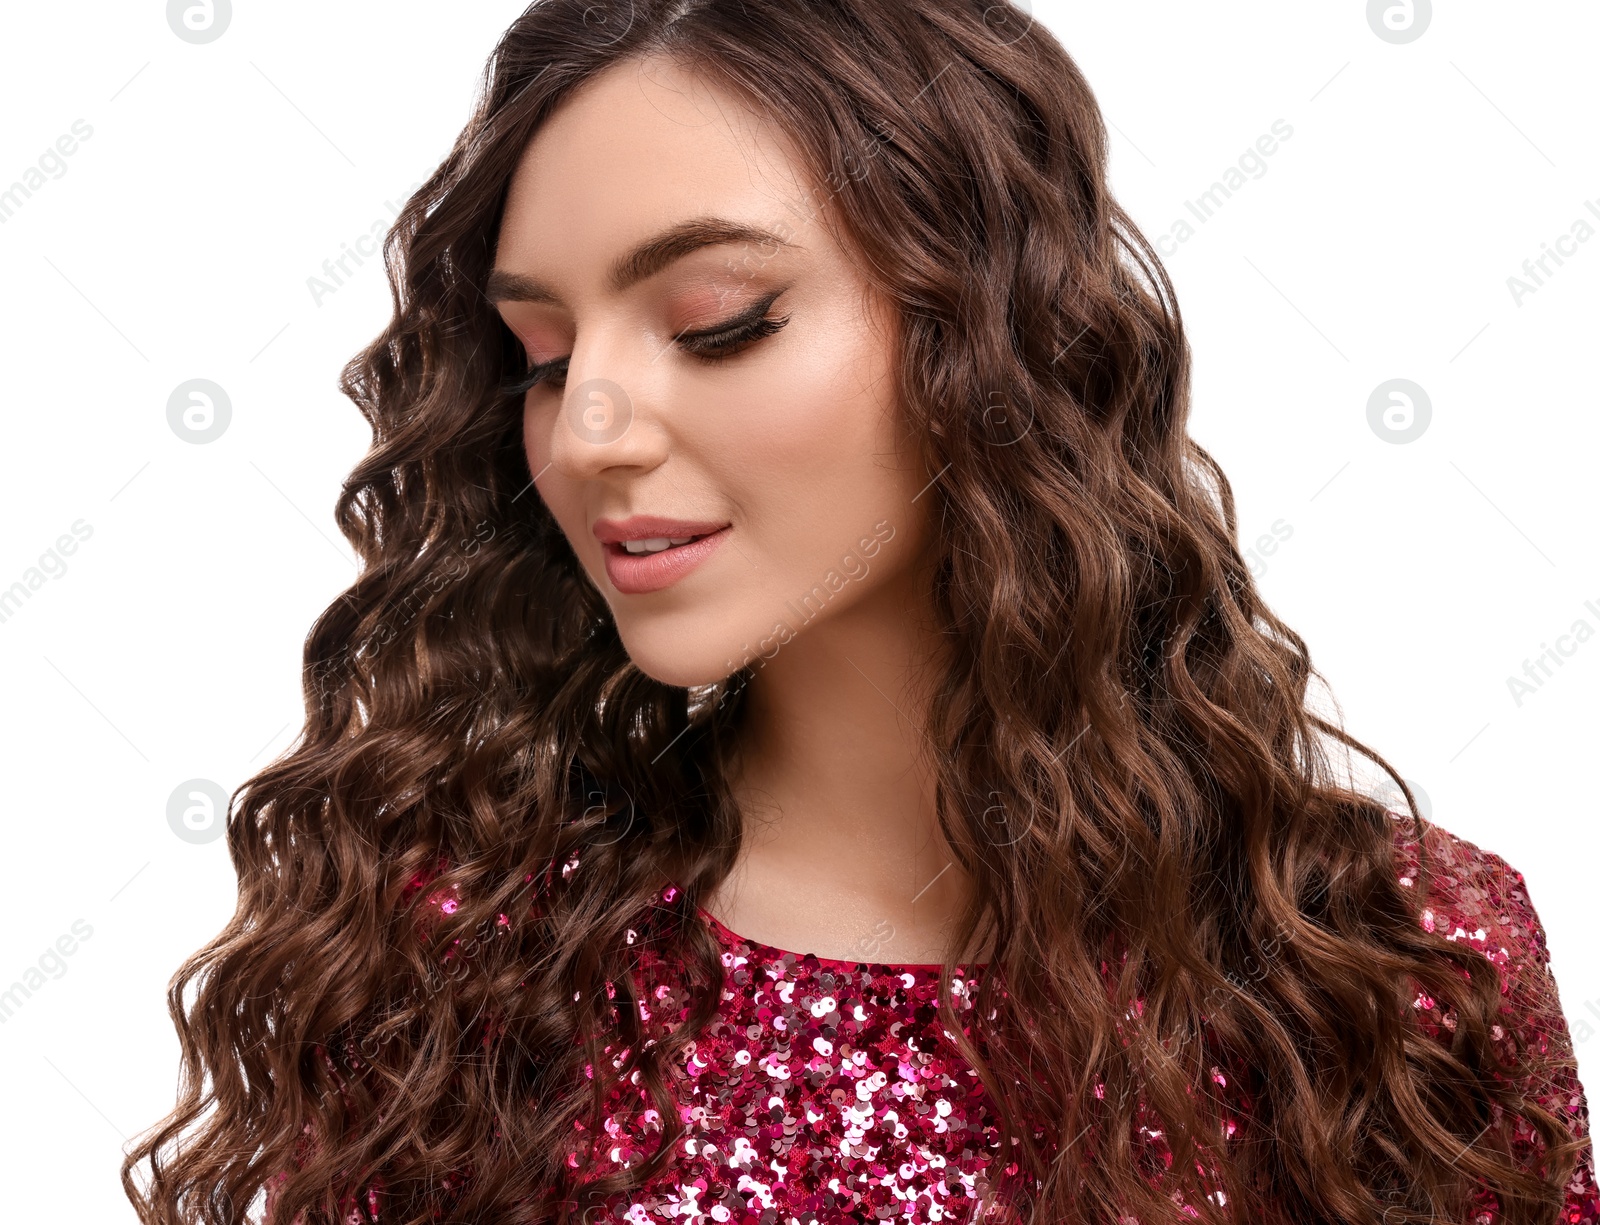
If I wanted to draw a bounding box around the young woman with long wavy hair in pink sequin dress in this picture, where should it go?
[123,0,1600,1225]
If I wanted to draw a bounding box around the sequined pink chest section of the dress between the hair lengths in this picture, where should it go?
[568,945,1014,1225]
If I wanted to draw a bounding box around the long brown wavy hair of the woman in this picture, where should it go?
[122,0,1581,1225]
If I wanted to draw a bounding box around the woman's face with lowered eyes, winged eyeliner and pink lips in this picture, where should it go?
[488,58,931,686]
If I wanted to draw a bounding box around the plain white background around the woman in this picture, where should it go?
[0,0,1600,1222]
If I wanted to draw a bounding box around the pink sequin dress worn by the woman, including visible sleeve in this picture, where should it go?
[268,822,1600,1225]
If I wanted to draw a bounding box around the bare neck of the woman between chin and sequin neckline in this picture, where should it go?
[706,566,970,963]
